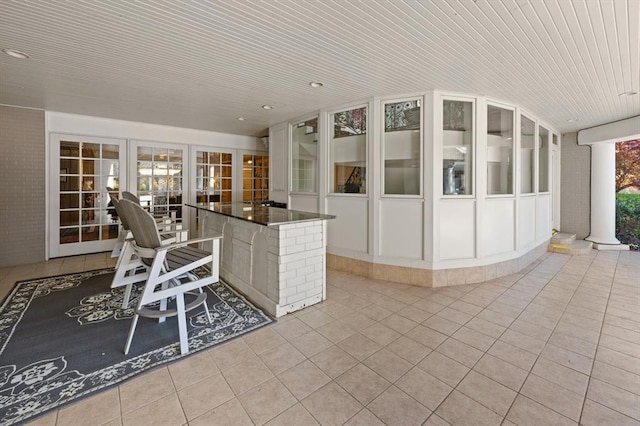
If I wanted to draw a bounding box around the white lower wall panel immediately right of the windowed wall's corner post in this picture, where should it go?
[438,200,476,260]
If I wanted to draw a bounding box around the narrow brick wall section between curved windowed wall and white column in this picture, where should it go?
[560,133,591,239]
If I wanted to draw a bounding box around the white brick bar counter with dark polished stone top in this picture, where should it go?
[187,203,335,317]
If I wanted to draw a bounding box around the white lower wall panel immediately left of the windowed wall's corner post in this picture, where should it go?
[379,199,424,259]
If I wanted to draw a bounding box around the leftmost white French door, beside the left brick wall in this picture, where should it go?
[49,134,126,257]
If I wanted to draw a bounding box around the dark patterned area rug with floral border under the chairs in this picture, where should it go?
[0,269,273,425]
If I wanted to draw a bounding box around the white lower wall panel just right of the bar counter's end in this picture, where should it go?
[327,197,369,253]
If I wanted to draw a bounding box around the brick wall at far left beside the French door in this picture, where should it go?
[0,106,46,267]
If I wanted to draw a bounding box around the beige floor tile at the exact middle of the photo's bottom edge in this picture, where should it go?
[302,382,362,425]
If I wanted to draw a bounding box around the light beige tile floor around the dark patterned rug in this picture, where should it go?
[0,251,640,426]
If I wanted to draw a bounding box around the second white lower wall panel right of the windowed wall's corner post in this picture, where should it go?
[482,199,515,256]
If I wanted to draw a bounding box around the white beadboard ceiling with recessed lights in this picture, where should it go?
[0,0,640,136]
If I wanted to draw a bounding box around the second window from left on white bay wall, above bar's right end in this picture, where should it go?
[329,107,367,194]
